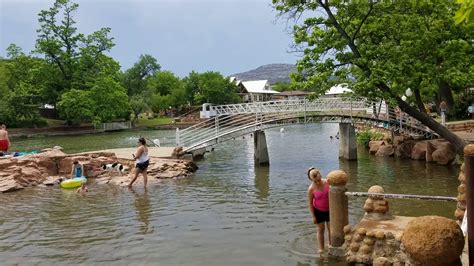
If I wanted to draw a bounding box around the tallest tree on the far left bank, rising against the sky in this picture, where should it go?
[35,0,114,104]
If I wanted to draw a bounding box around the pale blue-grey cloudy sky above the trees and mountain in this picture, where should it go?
[0,0,298,77]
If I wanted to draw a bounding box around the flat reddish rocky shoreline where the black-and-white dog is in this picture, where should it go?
[0,147,197,193]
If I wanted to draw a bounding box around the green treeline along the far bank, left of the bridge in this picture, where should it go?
[0,0,239,127]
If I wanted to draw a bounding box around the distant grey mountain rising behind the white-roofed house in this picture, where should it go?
[231,64,296,84]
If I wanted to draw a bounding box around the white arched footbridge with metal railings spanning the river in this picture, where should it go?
[176,98,437,160]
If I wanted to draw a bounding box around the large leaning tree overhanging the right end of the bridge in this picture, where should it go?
[273,0,472,154]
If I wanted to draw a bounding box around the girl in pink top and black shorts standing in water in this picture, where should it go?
[308,167,331,255]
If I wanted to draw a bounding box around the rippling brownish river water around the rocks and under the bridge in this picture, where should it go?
[0,124,458,265]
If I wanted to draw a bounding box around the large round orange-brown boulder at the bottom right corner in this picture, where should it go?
[401,216,464,265]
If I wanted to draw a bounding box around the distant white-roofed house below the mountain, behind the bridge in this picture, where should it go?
[231,77,279,103]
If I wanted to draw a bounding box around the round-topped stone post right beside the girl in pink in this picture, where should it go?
[327,170,349,257]
